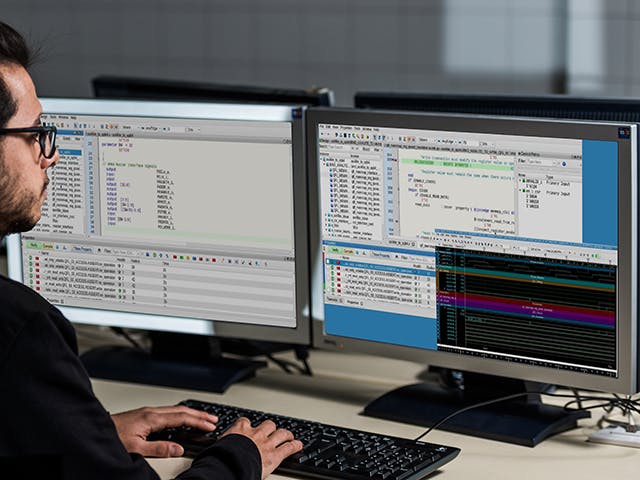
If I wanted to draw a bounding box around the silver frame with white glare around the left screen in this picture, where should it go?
[7,98,311,345]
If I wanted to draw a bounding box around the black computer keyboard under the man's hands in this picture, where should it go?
[149,400,460,480]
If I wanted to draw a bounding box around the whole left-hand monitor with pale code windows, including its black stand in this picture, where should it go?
[8,99,310,391]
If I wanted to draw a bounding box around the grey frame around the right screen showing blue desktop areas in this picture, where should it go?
[307,109,638,394]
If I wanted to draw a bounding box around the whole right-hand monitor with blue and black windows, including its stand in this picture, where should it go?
[307,109,638,446]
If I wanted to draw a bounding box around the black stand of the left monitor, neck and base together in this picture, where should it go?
[81,332,266,393]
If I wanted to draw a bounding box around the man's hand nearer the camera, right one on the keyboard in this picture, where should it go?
[221,417,303,480]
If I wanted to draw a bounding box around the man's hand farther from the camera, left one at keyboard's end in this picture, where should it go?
[111,406,218,457]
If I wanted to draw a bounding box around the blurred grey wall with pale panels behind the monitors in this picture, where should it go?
[0,0,640,106]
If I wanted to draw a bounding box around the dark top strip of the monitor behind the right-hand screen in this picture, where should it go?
[354,92,640,123]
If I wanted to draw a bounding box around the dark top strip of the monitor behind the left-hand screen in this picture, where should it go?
[91,75,335,107]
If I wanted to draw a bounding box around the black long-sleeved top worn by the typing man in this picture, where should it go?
[0,276,262,480]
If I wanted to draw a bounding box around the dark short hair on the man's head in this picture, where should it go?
[0,22,33,127]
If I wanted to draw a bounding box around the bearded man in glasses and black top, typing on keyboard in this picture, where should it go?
[0,22,302,480]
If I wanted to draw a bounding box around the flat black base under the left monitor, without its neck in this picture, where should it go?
[80,346,267,393]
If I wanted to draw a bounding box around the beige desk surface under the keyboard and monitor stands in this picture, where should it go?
[93,352,640,480]
